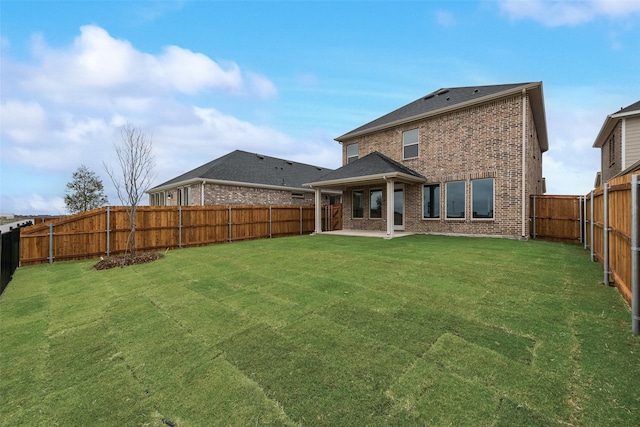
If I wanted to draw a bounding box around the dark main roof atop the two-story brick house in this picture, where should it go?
[336,83,532,141]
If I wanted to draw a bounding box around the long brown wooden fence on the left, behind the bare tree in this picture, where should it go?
[20,206,341,265]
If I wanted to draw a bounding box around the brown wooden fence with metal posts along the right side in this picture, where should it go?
[531,172,640,335]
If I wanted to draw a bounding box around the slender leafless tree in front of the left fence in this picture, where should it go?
[104,123,155,257]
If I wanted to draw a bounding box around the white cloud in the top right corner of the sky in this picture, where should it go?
[499,0,640,27]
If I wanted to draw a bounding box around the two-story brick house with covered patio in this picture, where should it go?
[307,82,548,238]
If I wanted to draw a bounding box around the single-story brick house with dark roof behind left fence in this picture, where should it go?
[147,150,340,206]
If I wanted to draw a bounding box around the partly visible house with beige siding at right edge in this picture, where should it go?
[593,101,640,186]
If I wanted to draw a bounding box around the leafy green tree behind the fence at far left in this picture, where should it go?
[64,165,109,214]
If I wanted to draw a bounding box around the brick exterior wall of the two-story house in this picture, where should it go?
[342,95,542,238]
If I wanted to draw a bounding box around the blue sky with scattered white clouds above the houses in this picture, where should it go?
[0,0,640,214]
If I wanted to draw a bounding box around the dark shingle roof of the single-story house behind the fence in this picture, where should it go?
[149,150,332,191]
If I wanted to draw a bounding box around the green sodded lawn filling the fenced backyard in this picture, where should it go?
[0,235,640,426]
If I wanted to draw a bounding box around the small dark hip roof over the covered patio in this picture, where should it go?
[309,151,425,183]
